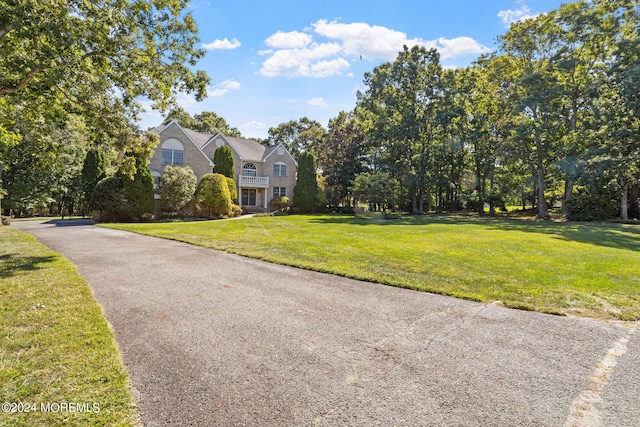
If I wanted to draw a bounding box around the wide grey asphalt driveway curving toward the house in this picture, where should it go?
[14,221,640,427]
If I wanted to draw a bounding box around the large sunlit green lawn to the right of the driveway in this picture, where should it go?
[105,215,640,320]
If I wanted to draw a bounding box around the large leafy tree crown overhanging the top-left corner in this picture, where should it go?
[0,0,209,174]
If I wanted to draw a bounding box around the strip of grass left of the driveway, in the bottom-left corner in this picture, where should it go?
[0,227,139,426]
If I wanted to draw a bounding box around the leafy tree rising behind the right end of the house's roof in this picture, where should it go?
[269,117,326,160]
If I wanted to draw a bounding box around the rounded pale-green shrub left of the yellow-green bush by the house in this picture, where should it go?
[159,165,197,212]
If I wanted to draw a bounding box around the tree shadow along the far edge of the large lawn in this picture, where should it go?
[310,215,640,251]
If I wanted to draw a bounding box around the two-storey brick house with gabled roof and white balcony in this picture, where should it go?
[149,120,297,212]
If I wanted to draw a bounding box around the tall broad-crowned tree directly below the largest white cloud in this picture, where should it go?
[357,46,443,214]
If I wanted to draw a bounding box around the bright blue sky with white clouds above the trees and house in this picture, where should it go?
[140,0,566,138]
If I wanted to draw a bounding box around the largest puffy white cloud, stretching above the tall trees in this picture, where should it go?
[258,19,490,78]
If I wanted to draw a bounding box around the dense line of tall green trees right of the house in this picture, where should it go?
[316,0,640,219]
